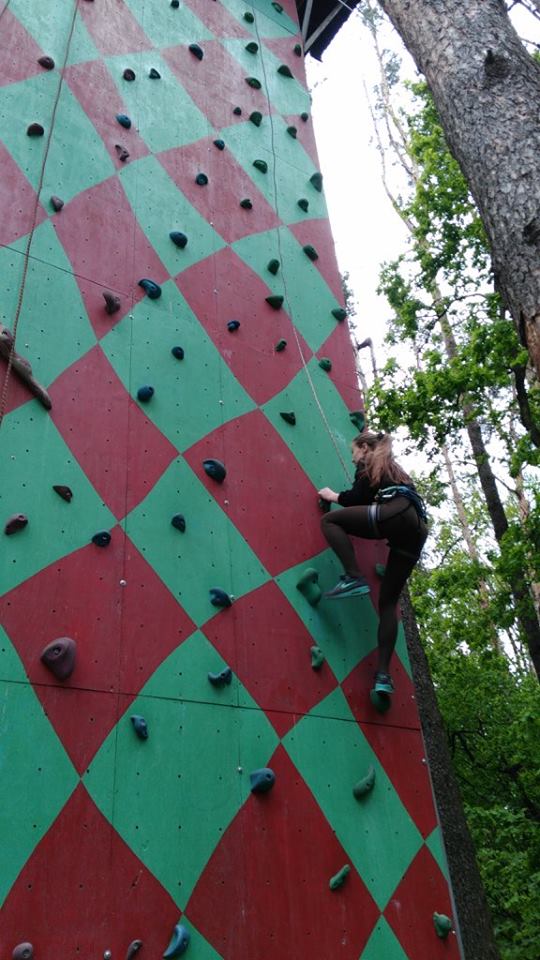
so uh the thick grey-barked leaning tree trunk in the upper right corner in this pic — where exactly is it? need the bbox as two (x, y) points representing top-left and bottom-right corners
(379, 0), (540, 376)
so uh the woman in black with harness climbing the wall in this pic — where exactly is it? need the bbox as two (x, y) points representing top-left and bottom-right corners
(319, 430), (428, 696)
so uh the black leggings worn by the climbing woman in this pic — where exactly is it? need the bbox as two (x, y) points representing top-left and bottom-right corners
(322, 497), (428, 673)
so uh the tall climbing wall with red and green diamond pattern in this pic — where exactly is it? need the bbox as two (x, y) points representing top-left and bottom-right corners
(0, 0), (459, 960)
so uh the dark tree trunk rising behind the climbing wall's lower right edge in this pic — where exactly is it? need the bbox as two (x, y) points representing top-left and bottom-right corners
(401, 590), (500, 960)
